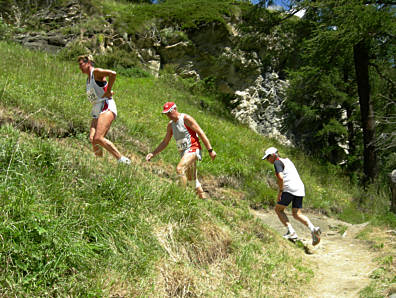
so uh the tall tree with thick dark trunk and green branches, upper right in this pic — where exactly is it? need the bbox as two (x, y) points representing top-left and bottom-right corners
(284, 0), (396, 183)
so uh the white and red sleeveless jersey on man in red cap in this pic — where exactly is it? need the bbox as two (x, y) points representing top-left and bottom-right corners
(171, 114), (201, 155)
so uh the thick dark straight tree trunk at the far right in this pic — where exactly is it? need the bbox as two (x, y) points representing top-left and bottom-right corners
(353, 40), (377, 184)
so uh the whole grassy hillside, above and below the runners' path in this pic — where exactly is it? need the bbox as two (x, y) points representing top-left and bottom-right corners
(0, 43), (394, 297)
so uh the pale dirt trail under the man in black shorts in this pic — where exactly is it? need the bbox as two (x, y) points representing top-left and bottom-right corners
(252, 211), (376, 298)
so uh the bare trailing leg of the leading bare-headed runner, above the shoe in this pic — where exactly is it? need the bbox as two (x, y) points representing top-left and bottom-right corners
(93, 111), (121, 160)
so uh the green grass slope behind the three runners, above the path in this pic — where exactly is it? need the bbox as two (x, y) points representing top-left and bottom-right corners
(0, 43), (387, 220)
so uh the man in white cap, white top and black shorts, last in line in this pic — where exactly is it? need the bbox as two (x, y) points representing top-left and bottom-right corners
(263, 147), (321, 245)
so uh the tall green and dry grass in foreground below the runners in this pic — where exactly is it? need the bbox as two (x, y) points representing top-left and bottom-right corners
(0, 126), (311, 297)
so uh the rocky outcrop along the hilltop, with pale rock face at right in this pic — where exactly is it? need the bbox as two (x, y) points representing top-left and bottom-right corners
(1, 1), (290, 144)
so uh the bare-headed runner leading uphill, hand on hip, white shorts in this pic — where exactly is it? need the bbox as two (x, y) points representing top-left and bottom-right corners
(77, 55), (131, 164)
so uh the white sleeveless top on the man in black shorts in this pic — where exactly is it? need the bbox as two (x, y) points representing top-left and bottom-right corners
(279, 158), (305, 197)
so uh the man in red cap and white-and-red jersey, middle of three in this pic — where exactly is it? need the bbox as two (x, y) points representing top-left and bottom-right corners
(146, 102), (216, 198)
